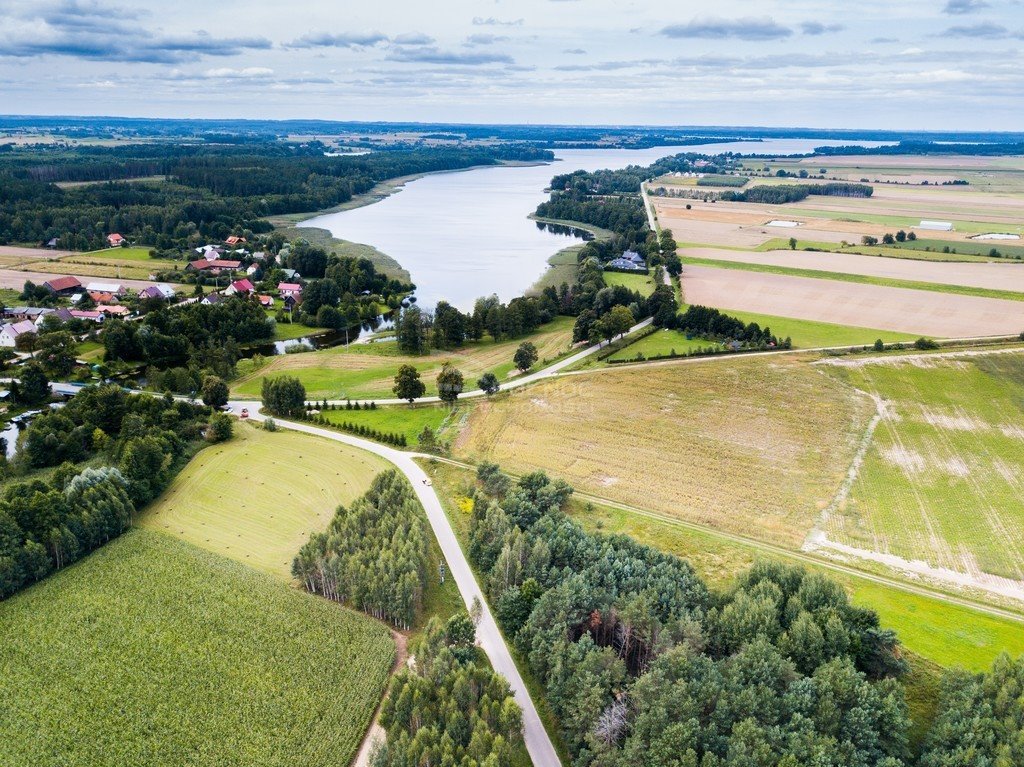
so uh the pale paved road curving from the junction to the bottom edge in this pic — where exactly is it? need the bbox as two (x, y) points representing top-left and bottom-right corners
(229, 401), (561, 767)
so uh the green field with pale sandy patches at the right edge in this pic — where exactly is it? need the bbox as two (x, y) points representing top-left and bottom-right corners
(820, 352), (1024, 581)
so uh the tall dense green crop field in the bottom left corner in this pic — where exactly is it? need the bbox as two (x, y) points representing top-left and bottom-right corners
(0, 530), (395, 767)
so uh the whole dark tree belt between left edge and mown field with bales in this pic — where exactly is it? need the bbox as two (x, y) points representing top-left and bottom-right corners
(0, 384), (210, 598)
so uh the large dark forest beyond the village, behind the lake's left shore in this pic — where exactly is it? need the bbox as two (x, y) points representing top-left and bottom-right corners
(0, 142), (551, 250)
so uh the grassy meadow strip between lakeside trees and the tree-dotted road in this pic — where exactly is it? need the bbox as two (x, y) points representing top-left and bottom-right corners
(231, 317), (573, 400)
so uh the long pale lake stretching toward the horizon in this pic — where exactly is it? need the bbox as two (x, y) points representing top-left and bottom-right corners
(299, 139), (882, 310)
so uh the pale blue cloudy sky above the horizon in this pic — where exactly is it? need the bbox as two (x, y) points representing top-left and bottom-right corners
(0, 0), (1024, 130)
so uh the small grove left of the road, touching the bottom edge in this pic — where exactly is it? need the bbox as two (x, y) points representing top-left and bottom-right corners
(370, 613), (522, 767)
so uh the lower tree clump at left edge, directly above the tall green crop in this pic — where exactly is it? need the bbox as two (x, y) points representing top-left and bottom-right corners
(0, 464), (135, 599)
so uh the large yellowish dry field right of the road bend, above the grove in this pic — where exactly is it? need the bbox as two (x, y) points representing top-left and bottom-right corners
(454, 356), (870, 546)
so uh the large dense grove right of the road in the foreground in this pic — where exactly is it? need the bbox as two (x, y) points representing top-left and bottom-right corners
(470, 464), (908, 767)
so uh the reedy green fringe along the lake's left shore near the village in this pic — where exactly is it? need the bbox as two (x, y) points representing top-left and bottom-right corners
(267, 158), (552, 283)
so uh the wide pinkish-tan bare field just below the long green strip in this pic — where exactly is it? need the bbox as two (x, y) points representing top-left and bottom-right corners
(683, 265), (1024, 338)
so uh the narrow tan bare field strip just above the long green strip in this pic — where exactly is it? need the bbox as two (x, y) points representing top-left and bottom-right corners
(682, 248), (1024, 293)
